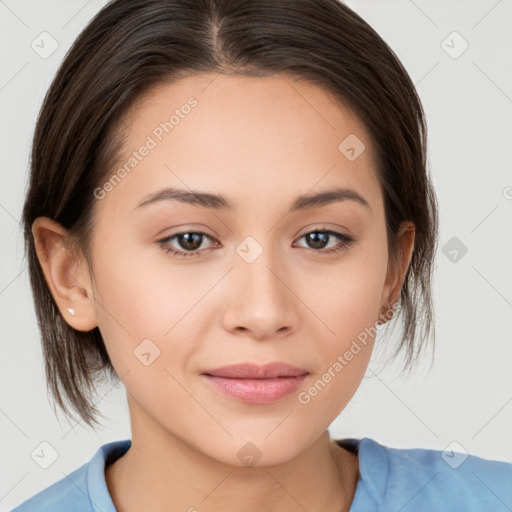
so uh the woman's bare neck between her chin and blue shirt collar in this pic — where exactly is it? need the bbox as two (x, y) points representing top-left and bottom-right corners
(105, 402), (359, 512)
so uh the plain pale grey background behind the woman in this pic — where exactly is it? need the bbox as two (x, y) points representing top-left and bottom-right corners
(0, 0), (512, 511)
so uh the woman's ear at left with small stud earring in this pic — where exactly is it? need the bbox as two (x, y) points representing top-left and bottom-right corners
(32, 217), (98, 331)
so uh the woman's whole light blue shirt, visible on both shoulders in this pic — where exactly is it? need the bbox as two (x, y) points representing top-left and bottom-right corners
(11, 437), (512, 512)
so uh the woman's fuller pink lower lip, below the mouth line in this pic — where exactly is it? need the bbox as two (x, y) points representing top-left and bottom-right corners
(202, 374), (307, 404)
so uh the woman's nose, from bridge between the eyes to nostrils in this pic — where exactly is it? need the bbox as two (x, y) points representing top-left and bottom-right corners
(223, 239), (304, 340)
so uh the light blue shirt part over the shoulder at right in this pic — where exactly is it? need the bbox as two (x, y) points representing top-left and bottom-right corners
(340, 438), (512, 512)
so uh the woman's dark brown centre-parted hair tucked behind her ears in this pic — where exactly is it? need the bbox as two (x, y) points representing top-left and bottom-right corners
(23, 0), (438, 426)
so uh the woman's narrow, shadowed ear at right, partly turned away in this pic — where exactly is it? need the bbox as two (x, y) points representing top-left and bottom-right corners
(377, 221), (416, 324)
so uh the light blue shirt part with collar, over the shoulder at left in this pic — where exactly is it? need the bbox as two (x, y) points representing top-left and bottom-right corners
(11, 439), (131, 512)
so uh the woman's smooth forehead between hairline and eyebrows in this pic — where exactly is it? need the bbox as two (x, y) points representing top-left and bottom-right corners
(100, 73), (381, 214)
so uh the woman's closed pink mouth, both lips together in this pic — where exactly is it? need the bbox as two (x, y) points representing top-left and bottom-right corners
(201, 362), (309, 404)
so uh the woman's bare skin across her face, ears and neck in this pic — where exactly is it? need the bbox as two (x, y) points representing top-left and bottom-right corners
(33, 74), (414, 512)
